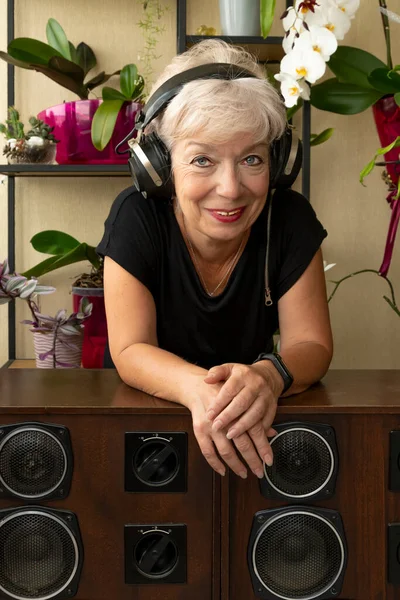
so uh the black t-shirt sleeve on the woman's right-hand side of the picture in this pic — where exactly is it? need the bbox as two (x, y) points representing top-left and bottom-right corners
(271, 190), (328, 300)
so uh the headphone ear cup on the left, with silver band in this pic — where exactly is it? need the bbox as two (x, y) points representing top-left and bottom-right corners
(128, 132), (174, 199)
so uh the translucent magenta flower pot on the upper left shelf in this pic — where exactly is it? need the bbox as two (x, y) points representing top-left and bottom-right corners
(37, 100), (142, 165)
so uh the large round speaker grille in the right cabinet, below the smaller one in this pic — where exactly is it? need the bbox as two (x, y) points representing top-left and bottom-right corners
(252, 511), (345, 600)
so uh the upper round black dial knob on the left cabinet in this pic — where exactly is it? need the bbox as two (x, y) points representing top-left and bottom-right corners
(133, 438), (179, 485)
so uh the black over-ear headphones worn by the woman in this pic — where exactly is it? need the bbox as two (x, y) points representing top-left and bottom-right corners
(116, 63), (302, 198)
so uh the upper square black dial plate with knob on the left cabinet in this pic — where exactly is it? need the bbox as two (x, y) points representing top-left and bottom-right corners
(125, 431), (187, 494)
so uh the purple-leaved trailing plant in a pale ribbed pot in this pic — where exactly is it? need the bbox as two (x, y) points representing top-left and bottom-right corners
(0, 260), (92, 369)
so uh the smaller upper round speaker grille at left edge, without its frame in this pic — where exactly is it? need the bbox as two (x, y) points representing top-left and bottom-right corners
(0, 427), (67, 499)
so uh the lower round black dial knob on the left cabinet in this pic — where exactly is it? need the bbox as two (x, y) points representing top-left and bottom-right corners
(134, 531), (178, 579)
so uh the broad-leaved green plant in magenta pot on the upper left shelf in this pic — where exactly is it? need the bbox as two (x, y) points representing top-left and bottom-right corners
(0, 19), (144, 164)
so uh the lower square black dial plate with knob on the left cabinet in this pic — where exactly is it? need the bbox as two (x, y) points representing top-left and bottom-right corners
(125, 523), (187, 584)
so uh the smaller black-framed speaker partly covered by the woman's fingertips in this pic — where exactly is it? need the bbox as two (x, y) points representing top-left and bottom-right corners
(260, 422), (339, 502)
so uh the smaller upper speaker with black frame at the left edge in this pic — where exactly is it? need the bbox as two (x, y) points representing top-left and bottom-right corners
(0, 422), (73, 501)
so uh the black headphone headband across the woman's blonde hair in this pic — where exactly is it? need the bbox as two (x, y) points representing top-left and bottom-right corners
(135, 63), (256, 130)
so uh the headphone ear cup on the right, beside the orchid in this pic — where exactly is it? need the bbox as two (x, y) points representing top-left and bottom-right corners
(270, 127), (303, 189)
